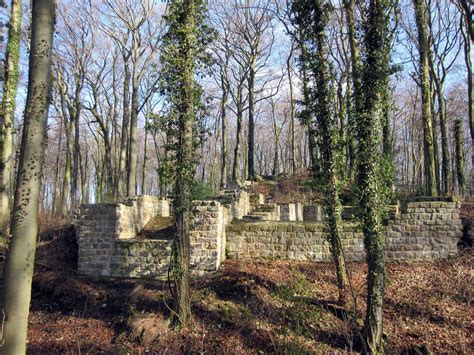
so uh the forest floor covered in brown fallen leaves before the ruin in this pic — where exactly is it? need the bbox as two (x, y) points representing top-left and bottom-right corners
(0, 216), (474, 354)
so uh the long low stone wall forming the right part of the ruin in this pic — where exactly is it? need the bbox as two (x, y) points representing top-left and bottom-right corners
(226, 202), (462, 261)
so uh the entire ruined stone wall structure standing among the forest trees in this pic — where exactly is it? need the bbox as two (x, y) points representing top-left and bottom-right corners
(75, 190), (463, 278)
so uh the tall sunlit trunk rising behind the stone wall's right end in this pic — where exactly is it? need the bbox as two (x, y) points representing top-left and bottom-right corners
(413, 0), (438, 196)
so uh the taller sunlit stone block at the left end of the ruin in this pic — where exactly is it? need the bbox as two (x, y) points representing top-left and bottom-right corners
(75, 196), (226, 278)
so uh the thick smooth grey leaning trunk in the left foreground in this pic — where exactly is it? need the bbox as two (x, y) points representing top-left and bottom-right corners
(0, 0), (55, 354)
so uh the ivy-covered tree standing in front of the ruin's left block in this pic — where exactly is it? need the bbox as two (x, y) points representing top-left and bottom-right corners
(161, 0), (207, 327)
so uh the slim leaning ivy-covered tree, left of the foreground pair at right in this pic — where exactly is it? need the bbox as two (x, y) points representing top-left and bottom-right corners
(292, 0), (349, 301)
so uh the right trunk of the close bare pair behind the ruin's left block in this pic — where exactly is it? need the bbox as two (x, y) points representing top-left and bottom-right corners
(127, 69), (139, 197)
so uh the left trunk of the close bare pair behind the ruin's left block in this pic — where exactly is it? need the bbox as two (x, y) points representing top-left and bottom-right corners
(116, 60), (131, 197)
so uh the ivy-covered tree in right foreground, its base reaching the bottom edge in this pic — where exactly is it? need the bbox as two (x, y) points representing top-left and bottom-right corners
(357, 0), (391, 353)
